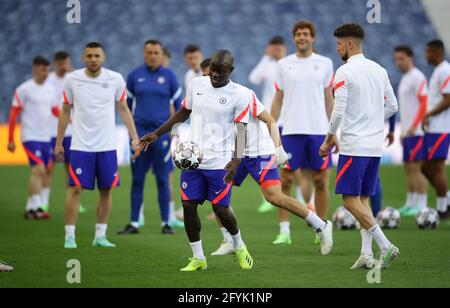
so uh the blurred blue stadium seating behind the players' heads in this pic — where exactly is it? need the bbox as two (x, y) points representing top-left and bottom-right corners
(0, 0), (436, 122)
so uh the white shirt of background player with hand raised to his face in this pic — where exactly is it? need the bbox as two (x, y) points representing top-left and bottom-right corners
(249, 55), (284, 126)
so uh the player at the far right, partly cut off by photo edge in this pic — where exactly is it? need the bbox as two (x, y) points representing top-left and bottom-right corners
(422, 40), (450, 219)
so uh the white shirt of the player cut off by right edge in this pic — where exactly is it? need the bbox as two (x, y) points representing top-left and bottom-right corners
(428, 61), (450, 134)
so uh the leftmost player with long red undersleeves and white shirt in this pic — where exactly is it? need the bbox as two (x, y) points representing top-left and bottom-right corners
(8, 56), (57, 220)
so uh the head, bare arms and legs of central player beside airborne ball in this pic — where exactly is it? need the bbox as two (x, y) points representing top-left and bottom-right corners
(141, 50), (247, 242)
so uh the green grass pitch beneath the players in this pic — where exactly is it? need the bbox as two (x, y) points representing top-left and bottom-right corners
(0, 166), (450, 288)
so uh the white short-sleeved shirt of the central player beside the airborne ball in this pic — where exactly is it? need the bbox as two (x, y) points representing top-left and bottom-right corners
(183, 77), (253, 170)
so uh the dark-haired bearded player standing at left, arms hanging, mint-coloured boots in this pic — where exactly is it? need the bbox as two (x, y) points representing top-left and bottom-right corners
(55, 42), (140, 249)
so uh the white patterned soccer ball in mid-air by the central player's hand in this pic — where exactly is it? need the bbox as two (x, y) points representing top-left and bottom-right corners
(172, 141), (203, 170)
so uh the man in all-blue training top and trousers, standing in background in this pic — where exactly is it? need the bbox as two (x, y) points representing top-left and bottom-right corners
(119, 40), (182, 235)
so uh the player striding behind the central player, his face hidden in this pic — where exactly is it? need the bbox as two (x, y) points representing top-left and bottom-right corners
(212, 93), (333, 256)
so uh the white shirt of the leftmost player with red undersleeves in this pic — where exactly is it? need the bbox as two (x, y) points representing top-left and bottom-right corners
(12, 79), (56, 142)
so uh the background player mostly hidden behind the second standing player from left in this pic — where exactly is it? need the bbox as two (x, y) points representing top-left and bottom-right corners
(41, 51), (86, 213)
